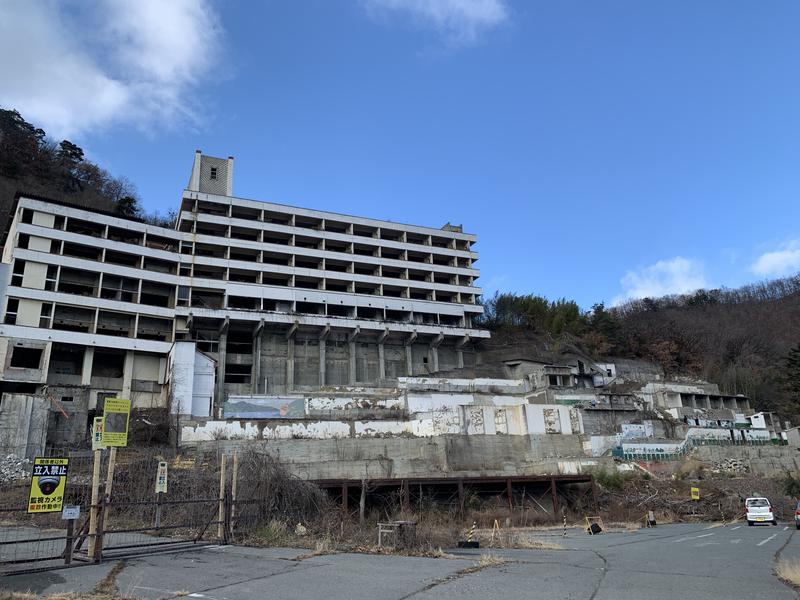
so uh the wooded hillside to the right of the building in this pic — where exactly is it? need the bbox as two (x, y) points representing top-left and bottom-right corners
(482, 282), (800, 424)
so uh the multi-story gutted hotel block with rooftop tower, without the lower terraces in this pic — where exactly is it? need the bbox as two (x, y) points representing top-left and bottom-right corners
(0, 151), (489, 440)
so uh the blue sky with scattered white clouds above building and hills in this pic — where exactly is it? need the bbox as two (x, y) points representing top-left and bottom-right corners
(0, 0), (800, 308)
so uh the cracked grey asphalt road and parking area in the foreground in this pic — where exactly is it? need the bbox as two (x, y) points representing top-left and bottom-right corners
(0, 524), (800, 600)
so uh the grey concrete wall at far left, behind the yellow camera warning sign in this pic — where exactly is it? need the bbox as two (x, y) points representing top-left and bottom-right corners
(0, 394), (49, 459)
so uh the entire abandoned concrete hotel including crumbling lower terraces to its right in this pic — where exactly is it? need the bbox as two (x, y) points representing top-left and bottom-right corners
(0, 152), (778, 485)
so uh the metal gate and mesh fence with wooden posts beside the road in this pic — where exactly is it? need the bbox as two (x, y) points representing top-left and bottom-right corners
(0, 448), (231, 576)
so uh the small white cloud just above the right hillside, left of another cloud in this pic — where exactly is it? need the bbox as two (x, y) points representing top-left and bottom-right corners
(612, 256), (709, 305)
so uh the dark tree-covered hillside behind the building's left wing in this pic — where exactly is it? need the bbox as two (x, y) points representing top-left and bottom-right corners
(0, 108), (171, 239)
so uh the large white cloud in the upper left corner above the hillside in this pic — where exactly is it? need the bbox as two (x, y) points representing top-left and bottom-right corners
(0, 0), (221, 138)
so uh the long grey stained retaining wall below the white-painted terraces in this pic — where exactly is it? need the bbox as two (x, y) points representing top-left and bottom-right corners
(197, 435), (610, 479)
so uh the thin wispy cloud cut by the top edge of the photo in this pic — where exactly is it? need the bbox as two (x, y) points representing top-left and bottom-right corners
(362, 0), (509, 44)
